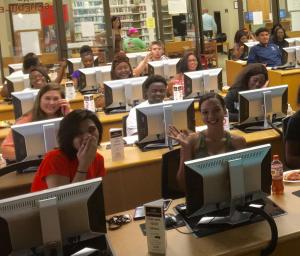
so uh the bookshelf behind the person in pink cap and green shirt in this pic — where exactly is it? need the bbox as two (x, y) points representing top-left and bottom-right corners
(109, 0), (155, 44)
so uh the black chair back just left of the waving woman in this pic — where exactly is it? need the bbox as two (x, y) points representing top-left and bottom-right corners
(161, 148), (185, 199)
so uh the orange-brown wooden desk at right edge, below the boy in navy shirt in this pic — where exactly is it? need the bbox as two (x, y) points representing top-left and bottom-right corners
(268, 69), (300, 111)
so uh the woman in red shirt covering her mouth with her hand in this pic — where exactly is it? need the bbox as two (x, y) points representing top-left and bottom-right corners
(31, 109), (105, 192)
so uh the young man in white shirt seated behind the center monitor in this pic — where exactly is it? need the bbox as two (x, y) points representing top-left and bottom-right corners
(126, 75), (167, 136)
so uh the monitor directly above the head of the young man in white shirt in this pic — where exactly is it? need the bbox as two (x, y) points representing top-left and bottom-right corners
(148, 58), (180, 79)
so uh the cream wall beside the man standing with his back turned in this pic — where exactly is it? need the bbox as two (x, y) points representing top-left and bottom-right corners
(201, 0), (239, 47)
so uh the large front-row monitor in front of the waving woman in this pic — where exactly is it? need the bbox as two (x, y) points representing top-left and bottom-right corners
(184, 144), (272, 224)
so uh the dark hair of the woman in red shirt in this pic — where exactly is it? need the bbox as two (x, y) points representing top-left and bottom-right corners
(57, 109), (103, 159)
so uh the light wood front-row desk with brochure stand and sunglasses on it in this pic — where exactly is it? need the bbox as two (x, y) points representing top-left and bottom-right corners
(108, 186), (300, 256)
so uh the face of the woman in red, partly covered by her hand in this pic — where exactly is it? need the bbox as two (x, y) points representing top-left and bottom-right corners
(73, 119), (99, 151)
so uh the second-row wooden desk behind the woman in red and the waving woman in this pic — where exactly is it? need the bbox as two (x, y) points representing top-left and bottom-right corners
(0, 130), (282, 214)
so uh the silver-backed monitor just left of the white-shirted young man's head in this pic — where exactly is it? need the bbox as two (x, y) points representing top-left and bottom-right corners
(104, 76), (147, 113)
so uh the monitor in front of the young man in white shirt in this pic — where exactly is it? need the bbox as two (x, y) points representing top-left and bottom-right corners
(136, 99), (195, 146)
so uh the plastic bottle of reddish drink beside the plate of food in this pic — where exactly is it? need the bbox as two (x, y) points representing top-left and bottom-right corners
(271, 155), (284, 195)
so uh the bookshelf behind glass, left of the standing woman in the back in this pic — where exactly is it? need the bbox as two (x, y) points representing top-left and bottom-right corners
(72, 0), (105, 42)
